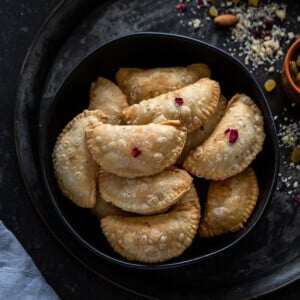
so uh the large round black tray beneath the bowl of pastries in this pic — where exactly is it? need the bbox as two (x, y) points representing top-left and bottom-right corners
(15, 0), (300, 299)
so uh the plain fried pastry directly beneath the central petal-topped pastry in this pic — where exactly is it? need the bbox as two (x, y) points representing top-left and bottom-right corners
(98, 167), (193, 215)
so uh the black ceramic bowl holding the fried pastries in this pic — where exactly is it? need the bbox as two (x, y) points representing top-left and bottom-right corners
(39, 33), (278, 269)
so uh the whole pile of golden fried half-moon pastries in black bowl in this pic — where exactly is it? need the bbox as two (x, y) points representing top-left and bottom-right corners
(52, 63), (265, 263)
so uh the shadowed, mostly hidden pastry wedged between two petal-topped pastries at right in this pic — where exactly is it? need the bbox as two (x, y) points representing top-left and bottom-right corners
(177, 95), (227, 165)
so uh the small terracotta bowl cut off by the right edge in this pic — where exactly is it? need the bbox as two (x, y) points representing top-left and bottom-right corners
(281, 39), (300, 105)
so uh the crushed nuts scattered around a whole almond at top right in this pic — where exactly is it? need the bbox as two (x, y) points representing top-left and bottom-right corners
(175, 0), (299, 73)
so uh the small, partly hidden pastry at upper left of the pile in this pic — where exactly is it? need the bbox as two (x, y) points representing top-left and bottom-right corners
(88, 77), (128, 124)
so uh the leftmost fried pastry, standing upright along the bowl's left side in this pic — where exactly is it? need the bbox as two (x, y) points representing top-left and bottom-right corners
(52, 110), (106, 208)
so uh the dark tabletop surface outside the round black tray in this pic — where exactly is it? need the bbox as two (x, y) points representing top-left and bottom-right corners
(0, 0), (300, 299)
